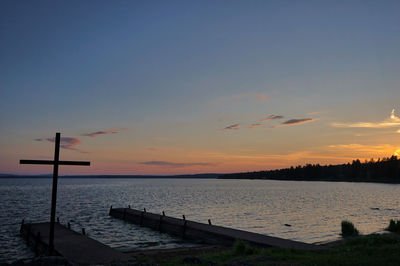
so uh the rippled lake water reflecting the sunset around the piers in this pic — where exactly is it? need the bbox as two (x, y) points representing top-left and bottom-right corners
(0, 178), (400, 262)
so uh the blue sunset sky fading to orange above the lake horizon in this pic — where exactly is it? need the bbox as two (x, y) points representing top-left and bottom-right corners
(0, 0), (400, 175)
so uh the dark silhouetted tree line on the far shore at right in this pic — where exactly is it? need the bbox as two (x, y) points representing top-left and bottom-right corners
(219, 156), (400, 183)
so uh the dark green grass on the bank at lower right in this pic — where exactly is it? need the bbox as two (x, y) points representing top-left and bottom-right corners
(152, 234), (400, 266)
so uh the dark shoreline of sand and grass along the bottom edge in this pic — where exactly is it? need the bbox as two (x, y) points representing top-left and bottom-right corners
(7, 232), (400, 266)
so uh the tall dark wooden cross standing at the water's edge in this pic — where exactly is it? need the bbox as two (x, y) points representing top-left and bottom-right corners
(19, 133), (90, 255)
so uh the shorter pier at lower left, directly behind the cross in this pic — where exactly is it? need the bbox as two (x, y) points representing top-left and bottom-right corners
(21, 223), (132, 265)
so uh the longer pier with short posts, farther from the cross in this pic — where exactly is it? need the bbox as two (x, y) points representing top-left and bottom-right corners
(109, 208), (320, 250)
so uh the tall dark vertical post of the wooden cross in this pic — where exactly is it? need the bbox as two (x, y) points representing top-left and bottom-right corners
(49, 133), (60, 255)
